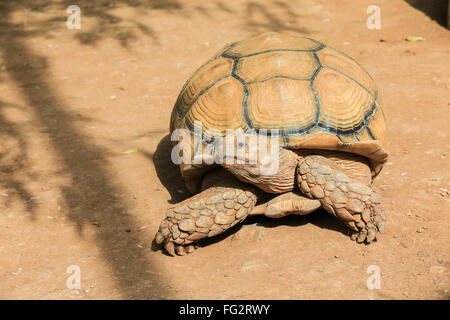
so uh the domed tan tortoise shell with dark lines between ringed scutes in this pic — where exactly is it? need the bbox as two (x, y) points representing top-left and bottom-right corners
(170, 32), (388, 191)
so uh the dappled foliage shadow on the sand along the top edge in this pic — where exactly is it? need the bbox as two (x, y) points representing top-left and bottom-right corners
(0, 0), (311, 48)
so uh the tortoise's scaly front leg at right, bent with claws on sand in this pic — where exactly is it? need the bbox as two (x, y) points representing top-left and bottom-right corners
(297, 155), (386, 243)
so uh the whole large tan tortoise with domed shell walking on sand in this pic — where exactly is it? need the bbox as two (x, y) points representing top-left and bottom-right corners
(155, 32), (388, 255)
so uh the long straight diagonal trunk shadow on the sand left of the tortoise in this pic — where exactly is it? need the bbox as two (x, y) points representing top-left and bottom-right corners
(0, 1), (174, 299)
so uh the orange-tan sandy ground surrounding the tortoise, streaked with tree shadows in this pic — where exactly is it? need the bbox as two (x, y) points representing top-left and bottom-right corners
(0, 0), (450, 299)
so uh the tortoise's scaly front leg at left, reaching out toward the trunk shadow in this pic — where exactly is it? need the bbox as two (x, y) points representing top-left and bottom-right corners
(155, 169), (256, 255)
